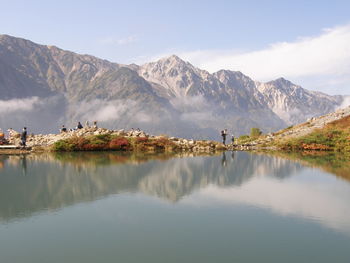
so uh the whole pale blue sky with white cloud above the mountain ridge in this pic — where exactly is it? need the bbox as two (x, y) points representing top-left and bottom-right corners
(0, 0), (350, 95)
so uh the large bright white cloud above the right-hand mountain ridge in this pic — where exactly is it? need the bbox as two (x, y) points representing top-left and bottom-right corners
(183, 25), (350, 80)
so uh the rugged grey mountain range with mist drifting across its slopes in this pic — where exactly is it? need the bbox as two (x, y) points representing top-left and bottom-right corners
(0, 35), (345, 138)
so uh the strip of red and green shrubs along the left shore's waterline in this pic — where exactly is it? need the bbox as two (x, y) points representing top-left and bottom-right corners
(52, 134), (178, 152)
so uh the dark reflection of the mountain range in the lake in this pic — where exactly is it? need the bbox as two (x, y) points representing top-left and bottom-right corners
(0, 152), (348, 228)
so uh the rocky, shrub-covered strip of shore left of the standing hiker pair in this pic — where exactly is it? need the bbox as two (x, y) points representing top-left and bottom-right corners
(0, 127), (229, 154)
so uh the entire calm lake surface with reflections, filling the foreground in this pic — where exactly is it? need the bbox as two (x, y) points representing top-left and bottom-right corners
(0, 152), (350, 263)
